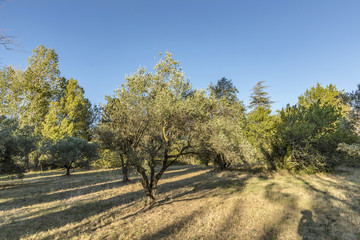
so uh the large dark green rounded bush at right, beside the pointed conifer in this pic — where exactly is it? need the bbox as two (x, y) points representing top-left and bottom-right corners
(267, 103), (355, 172)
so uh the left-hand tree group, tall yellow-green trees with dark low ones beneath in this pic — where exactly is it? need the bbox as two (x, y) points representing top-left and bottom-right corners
(0, 46), (97, 174)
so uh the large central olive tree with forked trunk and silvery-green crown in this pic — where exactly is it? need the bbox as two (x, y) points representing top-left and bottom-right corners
(103, 53), (207, 204)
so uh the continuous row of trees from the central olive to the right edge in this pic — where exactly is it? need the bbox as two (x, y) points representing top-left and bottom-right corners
(97, 53), (359, 202)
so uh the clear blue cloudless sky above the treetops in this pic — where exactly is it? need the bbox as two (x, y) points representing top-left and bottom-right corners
(0, 0), (360, 110)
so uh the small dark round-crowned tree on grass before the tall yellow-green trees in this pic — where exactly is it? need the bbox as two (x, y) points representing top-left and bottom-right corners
(42, 137), (98, 175)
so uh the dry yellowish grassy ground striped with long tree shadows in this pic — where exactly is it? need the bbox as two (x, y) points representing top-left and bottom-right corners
(0, 166), (360, 239)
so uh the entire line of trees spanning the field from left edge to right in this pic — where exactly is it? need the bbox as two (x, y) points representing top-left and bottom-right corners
(0, 46), (360, 203)
